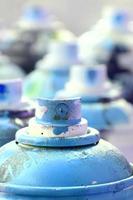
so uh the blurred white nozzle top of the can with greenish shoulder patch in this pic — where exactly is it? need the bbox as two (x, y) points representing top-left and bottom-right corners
(37, 40), (79, 70)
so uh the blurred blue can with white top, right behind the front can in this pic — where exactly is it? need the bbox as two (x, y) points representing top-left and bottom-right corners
(56, 65), (132, 130)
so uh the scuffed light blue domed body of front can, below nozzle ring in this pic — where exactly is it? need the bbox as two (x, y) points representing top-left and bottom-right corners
(0, 137), (133, 200)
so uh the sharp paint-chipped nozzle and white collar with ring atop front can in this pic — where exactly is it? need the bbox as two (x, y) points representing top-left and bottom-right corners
(16, 97), (100, 147)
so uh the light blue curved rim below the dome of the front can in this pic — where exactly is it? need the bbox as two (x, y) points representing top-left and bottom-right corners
(0, 164), (133, 197)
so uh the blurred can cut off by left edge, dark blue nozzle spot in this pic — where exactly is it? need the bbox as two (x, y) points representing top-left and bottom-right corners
(0, 80), (34, 146)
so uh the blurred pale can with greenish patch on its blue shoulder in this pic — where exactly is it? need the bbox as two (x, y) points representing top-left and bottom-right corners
(24, 41), (78, 98)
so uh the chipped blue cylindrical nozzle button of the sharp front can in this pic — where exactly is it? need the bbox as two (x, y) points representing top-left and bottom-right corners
(36, 98), (81, 128)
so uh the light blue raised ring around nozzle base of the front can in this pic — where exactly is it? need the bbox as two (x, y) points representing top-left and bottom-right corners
(16, 128), (100, 148)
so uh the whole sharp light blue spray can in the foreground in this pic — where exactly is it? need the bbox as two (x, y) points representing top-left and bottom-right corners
(0, 98), (133, 200)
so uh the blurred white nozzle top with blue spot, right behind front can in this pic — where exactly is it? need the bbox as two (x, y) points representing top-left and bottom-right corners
(57, 65), (121, 101)
